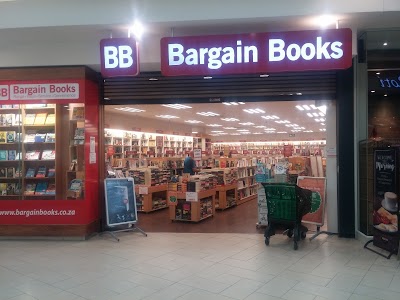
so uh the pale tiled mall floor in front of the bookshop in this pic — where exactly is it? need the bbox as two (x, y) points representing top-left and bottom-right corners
(0, 233), (400, 300)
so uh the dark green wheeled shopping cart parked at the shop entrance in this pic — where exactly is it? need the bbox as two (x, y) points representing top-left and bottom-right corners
(263, 183), (312, 250)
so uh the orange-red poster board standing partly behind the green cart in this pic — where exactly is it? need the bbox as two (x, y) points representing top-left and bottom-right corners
(297, 176), (326, 226)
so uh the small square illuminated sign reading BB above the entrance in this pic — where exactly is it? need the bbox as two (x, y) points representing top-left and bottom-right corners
(100, 38), (139, 78)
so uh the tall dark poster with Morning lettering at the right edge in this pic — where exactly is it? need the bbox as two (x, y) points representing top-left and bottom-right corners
(373, 149), (398, 252)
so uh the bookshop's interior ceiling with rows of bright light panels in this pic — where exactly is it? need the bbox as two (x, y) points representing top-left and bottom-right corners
(105, 100), (329, 140)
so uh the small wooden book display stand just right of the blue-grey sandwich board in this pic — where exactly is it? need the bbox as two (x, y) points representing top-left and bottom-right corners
(135, 184), (168, 213)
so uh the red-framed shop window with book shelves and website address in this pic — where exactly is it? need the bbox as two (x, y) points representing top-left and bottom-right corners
(0, 67), (99, 238)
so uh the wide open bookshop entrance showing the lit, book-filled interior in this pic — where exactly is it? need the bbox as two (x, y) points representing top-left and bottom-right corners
(104, 99), (337, 233)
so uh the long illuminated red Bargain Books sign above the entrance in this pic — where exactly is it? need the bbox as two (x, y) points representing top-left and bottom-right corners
(161, 29), (352, 76)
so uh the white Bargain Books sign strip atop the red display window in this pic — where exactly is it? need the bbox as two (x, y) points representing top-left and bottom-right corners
(0, 80), (80, 102)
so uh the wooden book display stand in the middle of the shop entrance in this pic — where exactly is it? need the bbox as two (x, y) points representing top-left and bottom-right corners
(168, 189), (216, 222)
